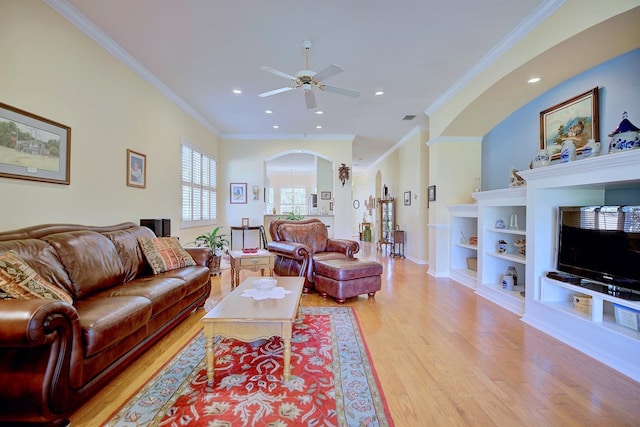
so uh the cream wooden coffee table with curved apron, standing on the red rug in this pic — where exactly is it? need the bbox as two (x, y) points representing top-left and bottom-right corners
(202, 277), (304, 385)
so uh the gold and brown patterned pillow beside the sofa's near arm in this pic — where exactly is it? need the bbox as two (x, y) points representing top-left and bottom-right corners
(0, 251), (73, 304)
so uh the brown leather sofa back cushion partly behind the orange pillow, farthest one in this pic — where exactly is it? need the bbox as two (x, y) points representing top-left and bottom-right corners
(103, 227), (156, 282)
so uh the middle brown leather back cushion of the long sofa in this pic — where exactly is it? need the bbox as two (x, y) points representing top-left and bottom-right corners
(42, 230), (125, 300)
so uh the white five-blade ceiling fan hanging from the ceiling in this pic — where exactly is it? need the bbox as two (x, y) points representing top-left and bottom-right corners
(258, 40), (360, 109)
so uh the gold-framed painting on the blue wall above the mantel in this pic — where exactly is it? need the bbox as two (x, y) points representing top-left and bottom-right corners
(540, 87), (600, 160)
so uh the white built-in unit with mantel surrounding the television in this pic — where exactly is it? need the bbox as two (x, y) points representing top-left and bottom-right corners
(520, 150), (640, 381)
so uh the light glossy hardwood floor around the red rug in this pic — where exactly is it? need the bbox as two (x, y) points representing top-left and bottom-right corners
(71, 242), (640, 427)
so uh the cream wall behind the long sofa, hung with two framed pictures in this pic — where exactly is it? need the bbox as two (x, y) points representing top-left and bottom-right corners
(0, 0), (219, 240)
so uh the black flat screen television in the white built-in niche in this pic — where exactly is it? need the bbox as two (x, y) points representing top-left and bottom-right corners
(557, 206), (640, 299)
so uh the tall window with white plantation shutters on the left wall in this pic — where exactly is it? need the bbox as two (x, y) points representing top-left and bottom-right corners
(182, 143), (217, 227)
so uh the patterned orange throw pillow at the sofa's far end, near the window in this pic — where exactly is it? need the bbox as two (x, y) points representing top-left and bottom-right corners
(138, 237), (196, 274)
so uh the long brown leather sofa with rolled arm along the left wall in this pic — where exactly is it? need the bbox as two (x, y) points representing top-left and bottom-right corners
(0, 223), (212, 426)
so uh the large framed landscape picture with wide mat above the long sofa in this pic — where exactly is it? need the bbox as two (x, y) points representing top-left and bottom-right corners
(0, 102), (71, 185)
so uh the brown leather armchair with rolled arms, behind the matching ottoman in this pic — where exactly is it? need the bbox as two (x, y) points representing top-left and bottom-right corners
(268, 218), (360, 292)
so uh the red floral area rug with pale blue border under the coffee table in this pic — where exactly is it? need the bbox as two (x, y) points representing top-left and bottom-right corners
(106, 307), (393, 427)
